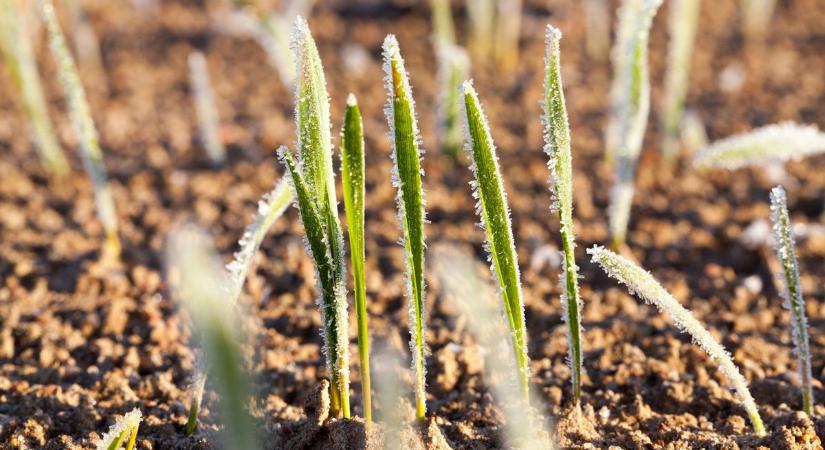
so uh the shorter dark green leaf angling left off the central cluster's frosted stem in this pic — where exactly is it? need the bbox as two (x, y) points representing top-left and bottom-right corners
(278, 147), (349, 418)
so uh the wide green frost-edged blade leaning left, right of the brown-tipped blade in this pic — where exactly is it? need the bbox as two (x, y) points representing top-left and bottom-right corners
(461, 81), (530, 400)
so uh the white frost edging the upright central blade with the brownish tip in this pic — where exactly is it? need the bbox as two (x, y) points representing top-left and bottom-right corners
(382, 34), (428, 414)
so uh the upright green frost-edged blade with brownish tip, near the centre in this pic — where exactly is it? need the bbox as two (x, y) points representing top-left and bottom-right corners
(383, 35), (427, 423)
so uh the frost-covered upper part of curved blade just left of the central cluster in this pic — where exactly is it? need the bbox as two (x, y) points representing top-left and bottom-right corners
(226, 179), (292, 304)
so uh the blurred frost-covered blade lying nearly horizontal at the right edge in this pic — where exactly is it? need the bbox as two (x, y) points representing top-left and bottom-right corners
(693, 122), (825, 169)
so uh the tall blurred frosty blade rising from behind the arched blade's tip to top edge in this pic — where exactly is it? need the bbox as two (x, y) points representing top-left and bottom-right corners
(607, 0), (662, 247)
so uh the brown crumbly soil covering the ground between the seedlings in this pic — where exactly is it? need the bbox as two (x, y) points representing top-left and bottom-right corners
(0, 0), (825, 449)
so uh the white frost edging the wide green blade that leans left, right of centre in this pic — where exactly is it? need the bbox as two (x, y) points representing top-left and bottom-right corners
(459, 80), (530, 390)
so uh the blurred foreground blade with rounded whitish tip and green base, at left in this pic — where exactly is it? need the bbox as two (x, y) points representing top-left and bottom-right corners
(171, 225), (260, 450)
